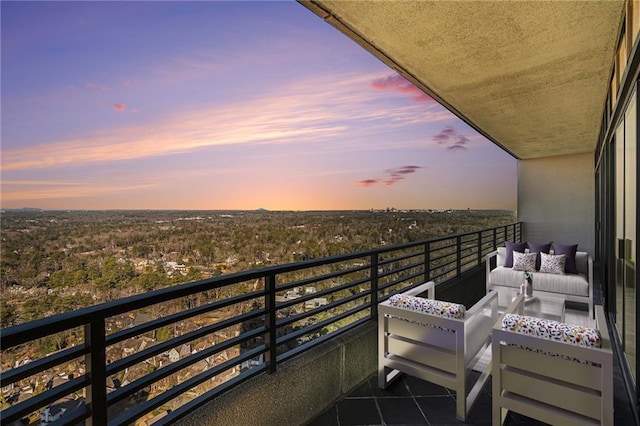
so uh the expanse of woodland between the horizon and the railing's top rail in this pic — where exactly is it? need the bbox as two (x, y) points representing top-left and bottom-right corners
(0, 209), (515, 327)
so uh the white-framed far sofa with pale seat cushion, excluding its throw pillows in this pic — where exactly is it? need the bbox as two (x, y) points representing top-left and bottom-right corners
(486, 247), (593, 318)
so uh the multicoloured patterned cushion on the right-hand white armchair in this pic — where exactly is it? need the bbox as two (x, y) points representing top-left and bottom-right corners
(502, 314), (602, 348)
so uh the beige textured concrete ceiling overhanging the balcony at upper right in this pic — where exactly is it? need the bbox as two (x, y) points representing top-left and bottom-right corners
(301, 0), (624, 159)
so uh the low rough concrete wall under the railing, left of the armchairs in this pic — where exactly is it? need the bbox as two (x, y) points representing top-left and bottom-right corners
(178, 321), (378, 426)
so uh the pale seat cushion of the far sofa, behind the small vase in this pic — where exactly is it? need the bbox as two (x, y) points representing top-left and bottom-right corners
(489, 266), (589, 297)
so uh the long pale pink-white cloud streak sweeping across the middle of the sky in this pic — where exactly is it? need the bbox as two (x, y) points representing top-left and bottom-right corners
(2, 74), (450, 171)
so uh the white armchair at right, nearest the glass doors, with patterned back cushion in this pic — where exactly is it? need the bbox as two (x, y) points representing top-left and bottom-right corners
(491, 295), (613, 426)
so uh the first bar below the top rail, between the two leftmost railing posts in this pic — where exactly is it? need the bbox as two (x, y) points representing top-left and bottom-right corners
(105, 291), (264, 346)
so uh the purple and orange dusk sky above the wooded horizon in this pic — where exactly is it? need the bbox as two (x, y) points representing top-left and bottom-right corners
(0, 1), (517, 210)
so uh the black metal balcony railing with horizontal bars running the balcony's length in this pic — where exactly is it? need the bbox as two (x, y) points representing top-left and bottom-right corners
(0, 223), (522, 425)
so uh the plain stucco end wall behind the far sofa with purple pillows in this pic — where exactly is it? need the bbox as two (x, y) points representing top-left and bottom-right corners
(518, 154), (595, 256)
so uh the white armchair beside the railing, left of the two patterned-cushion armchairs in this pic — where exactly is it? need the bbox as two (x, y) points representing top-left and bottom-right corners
(378, 281), (498, 421)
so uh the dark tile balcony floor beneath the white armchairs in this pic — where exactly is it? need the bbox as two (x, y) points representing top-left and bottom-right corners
(308, 362), (637, 426)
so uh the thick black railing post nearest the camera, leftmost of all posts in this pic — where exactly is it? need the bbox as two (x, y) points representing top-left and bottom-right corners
(84, 318), (107, 426)
